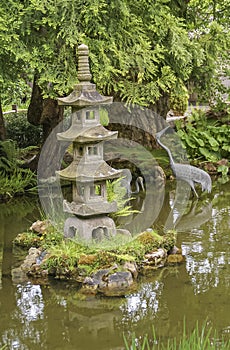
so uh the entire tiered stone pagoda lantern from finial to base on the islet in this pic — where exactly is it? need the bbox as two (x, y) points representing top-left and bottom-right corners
(57, 45), (121, 240)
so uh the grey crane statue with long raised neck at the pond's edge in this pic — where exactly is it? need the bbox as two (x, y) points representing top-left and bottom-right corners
(156, 126), (212, 197)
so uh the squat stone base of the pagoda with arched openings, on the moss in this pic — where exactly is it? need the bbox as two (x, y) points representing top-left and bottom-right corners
(64, 216), (116, 242)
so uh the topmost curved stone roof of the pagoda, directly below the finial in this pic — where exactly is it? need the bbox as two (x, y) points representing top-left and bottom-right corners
(57, 81), (113, 108)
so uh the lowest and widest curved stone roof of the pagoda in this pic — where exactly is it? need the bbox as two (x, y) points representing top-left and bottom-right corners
(56, 160), (122, 183)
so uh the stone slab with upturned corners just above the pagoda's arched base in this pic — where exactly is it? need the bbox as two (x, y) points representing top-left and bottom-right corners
(63, 200), (117, 216)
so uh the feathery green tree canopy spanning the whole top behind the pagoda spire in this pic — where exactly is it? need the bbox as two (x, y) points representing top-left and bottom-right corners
(0, 0), (229, 114)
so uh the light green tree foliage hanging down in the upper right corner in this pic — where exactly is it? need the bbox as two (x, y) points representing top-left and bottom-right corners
(186, 0), (230, 103)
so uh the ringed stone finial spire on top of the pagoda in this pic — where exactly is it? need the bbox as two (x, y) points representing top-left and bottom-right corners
(77, 44), (92, 82)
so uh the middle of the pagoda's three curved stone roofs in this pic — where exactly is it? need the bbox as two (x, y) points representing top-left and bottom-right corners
(57, 124), (118, 143)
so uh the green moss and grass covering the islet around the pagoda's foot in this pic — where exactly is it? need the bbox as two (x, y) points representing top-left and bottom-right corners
(14, 227), (176, 290)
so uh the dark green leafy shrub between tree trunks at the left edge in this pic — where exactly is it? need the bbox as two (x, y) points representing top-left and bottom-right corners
(5, 113), (42, 148)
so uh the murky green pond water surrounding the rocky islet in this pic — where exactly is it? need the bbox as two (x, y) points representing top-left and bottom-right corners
(0, 183), (230, 350)
